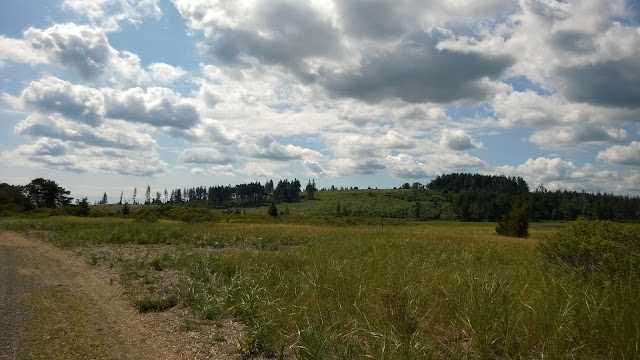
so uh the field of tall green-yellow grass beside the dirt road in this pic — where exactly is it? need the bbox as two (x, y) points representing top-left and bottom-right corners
(0, 217), (640, 359)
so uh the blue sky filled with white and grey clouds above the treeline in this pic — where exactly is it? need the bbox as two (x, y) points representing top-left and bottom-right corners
(0, 0), (640, 202)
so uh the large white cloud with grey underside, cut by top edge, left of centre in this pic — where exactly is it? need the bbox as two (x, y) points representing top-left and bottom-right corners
(173, 0), (341, 77)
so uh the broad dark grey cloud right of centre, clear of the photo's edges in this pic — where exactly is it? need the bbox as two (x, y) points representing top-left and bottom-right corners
(321, 32), (513, 103)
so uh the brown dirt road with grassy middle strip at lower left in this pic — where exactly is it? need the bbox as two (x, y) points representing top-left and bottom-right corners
(0, 231), (227, 360)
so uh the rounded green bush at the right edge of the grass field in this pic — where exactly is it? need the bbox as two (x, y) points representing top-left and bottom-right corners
(539, 219), (640, 277)
